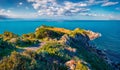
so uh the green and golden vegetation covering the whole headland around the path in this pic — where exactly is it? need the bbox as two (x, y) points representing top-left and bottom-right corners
(0, 25), (112, 70)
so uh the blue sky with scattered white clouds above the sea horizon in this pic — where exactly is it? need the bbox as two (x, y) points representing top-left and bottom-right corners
(0, 0), (120, 20)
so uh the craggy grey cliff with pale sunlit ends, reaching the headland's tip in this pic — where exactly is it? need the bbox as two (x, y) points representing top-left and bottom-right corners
(60, 30), (101, 45)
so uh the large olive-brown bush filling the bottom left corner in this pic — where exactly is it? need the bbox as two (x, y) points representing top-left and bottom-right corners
(0, 52), (37, 70)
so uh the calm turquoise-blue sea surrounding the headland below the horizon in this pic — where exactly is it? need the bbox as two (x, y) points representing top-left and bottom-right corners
(0, 20), (120, 60)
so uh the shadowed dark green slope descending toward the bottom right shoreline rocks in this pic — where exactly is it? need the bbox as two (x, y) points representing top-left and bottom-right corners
(71, 42), (113, 70)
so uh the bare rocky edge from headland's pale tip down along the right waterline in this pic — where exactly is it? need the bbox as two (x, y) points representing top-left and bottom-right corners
(60, 30), (120, 70)
